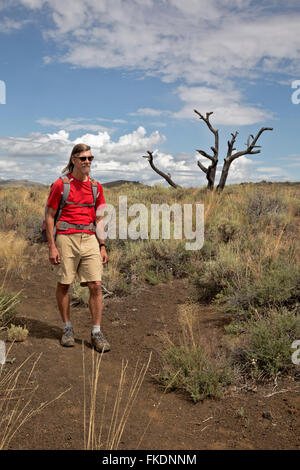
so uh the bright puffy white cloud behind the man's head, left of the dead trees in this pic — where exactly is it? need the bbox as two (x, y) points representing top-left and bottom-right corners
(0, 126), (165, 183)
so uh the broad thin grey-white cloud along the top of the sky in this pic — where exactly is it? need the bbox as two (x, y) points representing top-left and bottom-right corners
(17, 0), (300, 85)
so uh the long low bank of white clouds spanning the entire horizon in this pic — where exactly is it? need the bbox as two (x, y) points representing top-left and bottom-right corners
(0, 126), (294, 186)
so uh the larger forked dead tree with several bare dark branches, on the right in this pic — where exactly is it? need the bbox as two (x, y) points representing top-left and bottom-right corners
(194, 109), (273, 192)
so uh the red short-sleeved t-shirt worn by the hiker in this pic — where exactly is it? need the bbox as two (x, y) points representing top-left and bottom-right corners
(47, 173), (106, 234)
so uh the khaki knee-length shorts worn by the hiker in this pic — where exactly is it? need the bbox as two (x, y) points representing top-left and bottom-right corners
(55, 232), (103, 286)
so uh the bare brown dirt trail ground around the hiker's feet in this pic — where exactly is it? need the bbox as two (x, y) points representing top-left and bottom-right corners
(1, 246), (300, 450)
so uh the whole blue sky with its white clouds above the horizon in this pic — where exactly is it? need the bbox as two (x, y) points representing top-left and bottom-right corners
(0, 0), (300, 186)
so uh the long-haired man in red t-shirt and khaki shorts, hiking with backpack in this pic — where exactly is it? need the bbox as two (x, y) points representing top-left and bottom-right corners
(45, 144), (110, 352)
